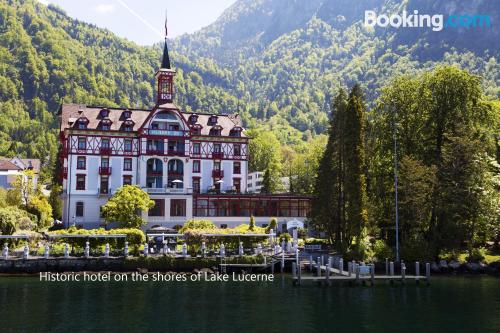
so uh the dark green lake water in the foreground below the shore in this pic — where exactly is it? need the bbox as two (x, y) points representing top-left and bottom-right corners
(0, 275), (500, 333)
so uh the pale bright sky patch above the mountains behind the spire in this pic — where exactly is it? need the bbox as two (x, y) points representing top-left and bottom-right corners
(39, 0), (235, 45)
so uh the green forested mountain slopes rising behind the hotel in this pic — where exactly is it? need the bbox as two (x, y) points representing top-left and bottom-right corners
(0, 0), (500, 179)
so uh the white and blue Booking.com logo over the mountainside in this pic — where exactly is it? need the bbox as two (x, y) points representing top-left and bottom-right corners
(365, 10), (491, 31)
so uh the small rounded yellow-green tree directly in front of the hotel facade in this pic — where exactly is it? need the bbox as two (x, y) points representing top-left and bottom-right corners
(102, 185), (154, 228)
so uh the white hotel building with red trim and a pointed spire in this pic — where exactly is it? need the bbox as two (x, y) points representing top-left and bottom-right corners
(59, 35), (309, 228)
